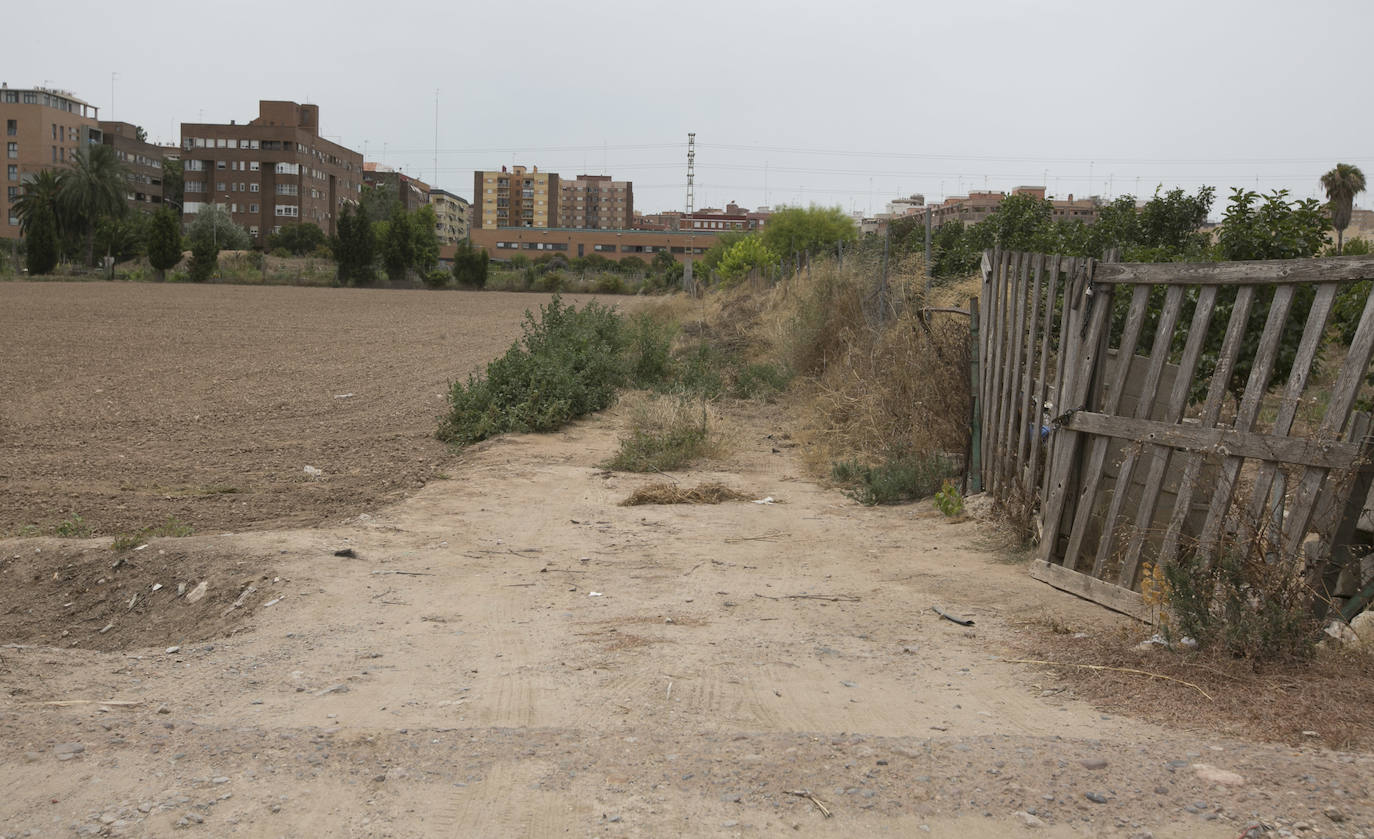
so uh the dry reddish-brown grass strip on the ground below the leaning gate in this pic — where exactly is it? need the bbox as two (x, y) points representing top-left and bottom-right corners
(1020, 623), (1374, 751)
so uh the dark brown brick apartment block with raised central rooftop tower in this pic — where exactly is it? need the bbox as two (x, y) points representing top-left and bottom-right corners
(181, 100), (363, 242)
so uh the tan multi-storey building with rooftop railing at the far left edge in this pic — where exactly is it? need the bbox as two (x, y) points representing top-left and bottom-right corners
(0, 84), (100, 239)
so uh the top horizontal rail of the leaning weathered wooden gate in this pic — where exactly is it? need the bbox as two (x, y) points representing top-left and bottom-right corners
(1094, 257), (1374, 286)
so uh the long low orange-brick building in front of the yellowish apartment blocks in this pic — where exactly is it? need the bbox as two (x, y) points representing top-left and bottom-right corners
(471, 227), (717, 262)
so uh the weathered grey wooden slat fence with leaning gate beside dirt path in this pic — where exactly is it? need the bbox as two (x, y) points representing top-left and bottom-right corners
(976, 251), (1374, 618)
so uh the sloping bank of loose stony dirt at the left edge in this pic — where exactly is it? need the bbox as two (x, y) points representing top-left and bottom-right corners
(0, 538), (283, 651)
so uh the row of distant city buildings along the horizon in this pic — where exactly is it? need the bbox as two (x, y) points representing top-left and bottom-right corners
(8, 82), (1374, 260)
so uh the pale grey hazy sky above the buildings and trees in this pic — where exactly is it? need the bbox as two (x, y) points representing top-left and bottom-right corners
(0, 0), (1374, 214)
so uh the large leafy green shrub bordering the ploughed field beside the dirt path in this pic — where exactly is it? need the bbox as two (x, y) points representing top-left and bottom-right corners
(438, 295), (629, 445)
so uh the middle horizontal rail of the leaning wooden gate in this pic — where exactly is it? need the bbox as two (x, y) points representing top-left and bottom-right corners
(1065, 411), (1359, 468)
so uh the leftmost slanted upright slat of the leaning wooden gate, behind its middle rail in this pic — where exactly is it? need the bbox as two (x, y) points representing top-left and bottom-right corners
(1040, 260), (1112, 562)
